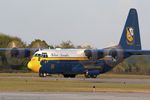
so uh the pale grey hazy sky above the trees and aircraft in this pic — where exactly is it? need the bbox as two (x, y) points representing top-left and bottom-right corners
(0, 0), (150, 49)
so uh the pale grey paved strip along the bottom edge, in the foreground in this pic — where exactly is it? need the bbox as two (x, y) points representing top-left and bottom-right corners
(0, 92), (150, 100)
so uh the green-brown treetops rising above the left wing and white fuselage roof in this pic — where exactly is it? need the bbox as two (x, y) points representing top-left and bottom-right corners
(0, 33), (92, 49)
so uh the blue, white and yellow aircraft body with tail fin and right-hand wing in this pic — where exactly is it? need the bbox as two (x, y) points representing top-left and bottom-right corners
(28, 8), (150, 78)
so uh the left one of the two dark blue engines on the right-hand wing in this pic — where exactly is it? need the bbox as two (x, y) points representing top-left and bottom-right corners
(84, 50), (104, 60)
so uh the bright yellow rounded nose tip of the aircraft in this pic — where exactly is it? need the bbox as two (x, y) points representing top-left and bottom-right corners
(27, 61), (41, 73)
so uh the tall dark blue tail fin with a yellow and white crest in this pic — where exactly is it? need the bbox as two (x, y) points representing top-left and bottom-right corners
(119, 8), (141, 50)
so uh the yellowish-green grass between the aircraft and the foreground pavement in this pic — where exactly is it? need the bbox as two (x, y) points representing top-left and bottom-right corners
(0, 73), (150, 92)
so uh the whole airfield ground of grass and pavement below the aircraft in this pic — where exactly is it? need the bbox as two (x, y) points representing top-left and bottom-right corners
(0, 74), (150, 96)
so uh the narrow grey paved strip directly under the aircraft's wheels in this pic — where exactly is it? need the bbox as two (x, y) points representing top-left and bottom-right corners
(0, 76), (150, 84)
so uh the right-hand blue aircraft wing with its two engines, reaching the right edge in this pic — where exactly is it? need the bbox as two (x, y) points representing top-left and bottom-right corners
(84, 48), (150, 60)
